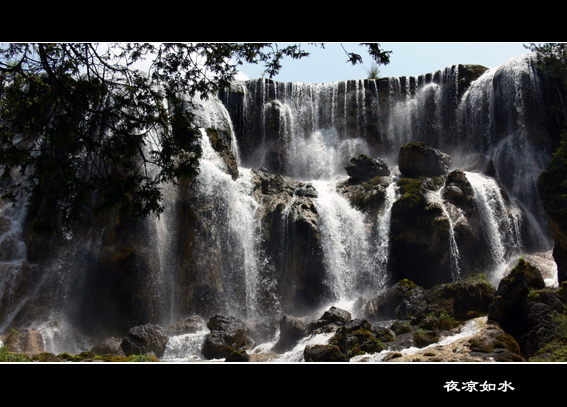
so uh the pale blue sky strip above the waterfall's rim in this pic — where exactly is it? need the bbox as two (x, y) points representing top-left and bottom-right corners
(235, 42), (529, 83)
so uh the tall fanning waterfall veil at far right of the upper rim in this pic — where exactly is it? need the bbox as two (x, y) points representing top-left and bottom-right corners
(455, 54), (551, 234)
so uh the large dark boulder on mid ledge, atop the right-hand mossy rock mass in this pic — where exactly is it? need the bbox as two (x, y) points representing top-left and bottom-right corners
(398, 142), (451, 178)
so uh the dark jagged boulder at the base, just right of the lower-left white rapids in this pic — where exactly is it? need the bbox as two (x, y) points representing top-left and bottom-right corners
(201, 314), (252, 359)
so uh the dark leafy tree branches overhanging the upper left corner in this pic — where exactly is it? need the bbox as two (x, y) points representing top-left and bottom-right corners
(0, 43), (390, 230)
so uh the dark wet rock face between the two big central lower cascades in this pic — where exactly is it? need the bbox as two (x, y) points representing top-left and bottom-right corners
(252, 169), (327, 314)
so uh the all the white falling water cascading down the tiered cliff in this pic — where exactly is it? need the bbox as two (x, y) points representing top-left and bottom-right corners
(0, 52), (551, 360)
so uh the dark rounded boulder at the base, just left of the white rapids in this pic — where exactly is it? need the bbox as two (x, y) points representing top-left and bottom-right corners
(120, 324), (169, 358)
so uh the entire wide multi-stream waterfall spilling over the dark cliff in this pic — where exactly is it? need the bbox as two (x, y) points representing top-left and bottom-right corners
(0, 51), (564, 360)
